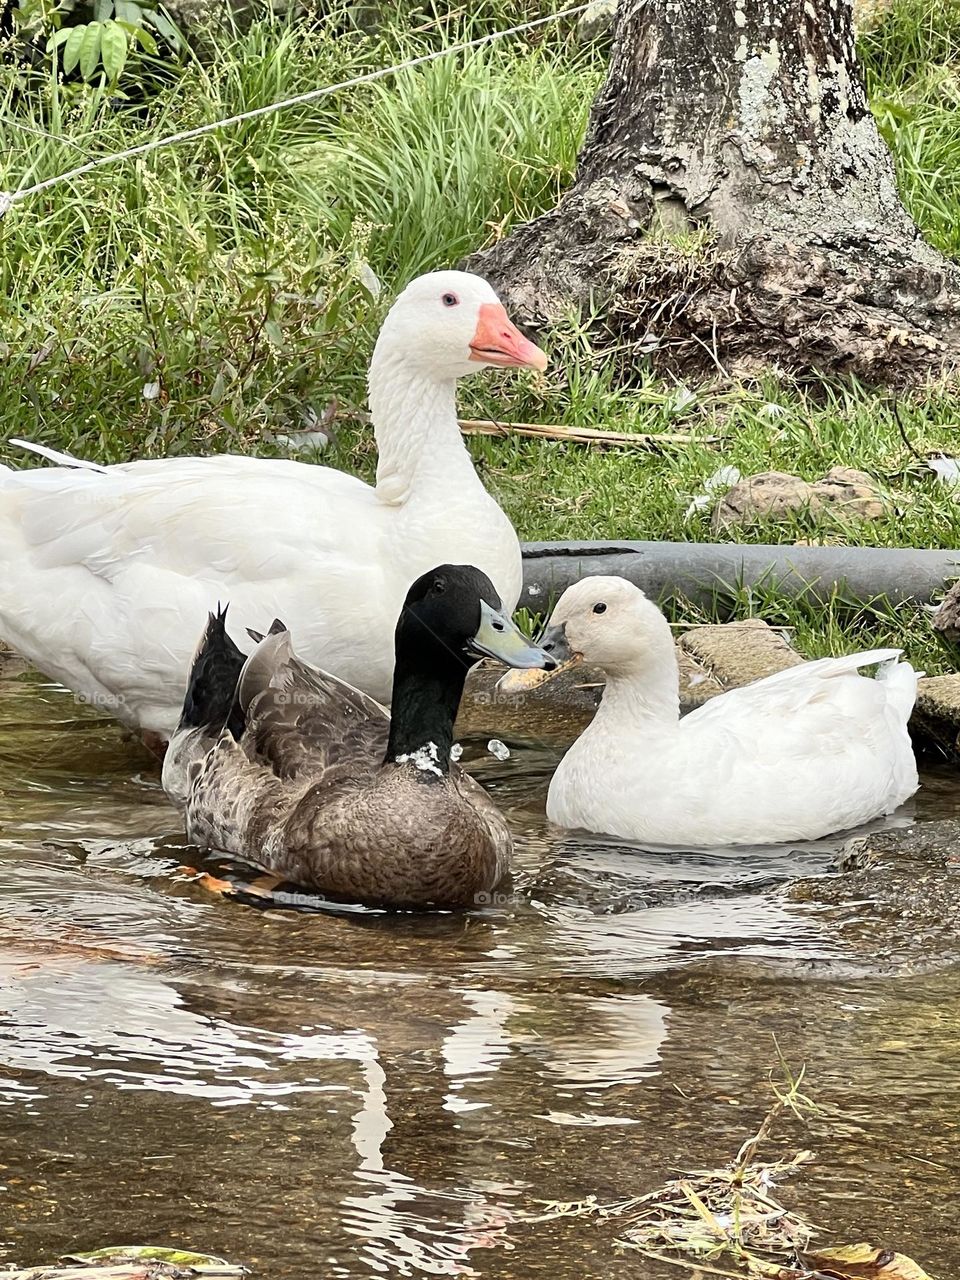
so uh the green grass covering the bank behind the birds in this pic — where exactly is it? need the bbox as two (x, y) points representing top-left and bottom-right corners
(0, 0), (960, 671)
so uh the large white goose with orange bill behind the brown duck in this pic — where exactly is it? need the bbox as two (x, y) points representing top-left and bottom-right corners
(0, 271), (547, 740)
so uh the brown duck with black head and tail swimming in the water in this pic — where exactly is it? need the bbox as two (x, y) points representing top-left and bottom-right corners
(164, 564), (554, 908)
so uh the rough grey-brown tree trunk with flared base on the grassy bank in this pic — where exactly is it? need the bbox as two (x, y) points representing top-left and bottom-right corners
(468, 0), (960, 384)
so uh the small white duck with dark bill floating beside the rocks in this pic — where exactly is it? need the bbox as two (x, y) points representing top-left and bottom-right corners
(500, 577), (918, 849)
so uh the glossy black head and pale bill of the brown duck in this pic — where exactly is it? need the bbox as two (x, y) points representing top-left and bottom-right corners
(397, 564), (556, 671)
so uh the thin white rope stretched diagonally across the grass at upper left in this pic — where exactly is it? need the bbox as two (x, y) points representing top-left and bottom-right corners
(0, 4), (590, 218)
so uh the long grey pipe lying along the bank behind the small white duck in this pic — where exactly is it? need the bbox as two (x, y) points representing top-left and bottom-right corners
(520, 543), (960, 617)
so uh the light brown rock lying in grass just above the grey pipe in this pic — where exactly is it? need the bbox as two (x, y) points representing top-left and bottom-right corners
(710, 467), (886, 532)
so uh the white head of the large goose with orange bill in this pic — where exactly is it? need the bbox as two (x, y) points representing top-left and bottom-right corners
(378, 271), (547, 381)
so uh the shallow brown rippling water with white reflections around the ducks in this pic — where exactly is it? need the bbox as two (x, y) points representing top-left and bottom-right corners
(0, 669), (960, 1280)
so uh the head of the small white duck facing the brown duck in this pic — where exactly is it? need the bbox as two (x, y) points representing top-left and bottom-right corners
(499, 575), (673, 692)
